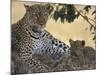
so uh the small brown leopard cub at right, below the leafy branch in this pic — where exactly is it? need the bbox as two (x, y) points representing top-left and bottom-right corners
(69, 39), (96, 70)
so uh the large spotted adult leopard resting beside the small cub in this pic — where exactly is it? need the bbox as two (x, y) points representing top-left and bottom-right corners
(11, 4), (70, 74)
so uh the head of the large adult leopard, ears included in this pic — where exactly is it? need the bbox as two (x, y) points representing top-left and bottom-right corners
(24, 4), (53, 28)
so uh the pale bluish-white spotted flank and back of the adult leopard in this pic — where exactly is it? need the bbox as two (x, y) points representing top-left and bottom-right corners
(32, 30), (70, 63)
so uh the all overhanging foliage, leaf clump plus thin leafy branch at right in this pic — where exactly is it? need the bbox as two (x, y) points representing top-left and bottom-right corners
(52, 4), (96, 40)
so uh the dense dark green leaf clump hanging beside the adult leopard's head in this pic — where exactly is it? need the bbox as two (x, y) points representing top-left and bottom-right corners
(53, 4), (79, 23)
